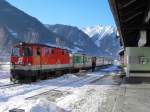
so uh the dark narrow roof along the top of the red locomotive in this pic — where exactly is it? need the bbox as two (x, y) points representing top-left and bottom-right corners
(14, 43), (69, 51)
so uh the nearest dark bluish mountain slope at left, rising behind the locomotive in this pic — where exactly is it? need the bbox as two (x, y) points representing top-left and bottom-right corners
(0, 0), (83, 61)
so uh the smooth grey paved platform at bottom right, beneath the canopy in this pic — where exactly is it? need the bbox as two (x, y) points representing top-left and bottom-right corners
(112, 83), (150, 112)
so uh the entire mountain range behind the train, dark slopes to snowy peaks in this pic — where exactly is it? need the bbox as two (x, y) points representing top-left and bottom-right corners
(0, 0), (118, 61)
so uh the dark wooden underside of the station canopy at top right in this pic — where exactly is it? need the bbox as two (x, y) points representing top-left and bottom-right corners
(109, 0), (150, 47)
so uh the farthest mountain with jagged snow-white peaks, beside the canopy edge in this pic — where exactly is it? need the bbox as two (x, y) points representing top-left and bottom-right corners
(82, 25), (120, 58)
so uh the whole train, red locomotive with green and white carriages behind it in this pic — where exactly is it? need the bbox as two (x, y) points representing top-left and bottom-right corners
(10, 43), (112, 82)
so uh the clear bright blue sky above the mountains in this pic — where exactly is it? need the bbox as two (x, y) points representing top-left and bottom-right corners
(7, 0), (115, 28)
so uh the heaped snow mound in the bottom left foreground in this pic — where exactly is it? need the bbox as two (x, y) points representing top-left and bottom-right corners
(0, 96), (69, 112)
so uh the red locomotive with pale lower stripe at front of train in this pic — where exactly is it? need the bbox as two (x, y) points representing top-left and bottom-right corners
(11, 43), (70, 80)
